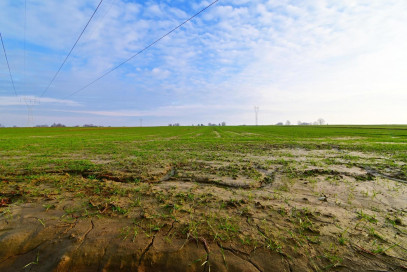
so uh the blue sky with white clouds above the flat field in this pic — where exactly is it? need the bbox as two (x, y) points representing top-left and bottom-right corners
(0, 0), (407, 126)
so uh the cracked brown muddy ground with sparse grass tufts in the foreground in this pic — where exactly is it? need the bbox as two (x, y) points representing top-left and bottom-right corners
(0, 144), (407, 271)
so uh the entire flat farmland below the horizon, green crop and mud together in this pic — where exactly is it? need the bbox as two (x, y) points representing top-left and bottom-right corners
(0, 126), (407, 271)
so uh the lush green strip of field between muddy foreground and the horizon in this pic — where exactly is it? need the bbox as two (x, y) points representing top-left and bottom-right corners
(0, 126), (407, 175)
